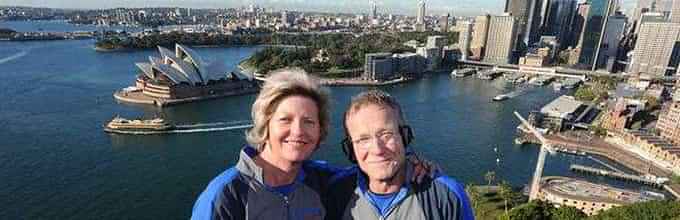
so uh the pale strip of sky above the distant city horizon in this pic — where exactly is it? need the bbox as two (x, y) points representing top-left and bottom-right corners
(0, 0), (636, 16)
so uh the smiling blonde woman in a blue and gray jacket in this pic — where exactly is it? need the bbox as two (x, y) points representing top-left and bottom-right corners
(191, 69), (430, 219)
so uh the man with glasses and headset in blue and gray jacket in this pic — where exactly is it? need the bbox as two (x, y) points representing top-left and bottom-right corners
(327, 90), (474, 220)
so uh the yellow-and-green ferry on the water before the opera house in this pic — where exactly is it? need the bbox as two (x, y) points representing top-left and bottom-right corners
(104, 116), (175, 133)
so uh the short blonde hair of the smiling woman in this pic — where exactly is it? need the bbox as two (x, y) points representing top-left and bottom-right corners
(246, 68), (330, 151)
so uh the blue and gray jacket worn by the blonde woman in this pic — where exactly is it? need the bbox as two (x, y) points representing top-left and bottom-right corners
(191, 147), (335, 220)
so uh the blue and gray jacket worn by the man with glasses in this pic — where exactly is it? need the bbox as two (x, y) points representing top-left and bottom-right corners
(326, 164), (475, 220)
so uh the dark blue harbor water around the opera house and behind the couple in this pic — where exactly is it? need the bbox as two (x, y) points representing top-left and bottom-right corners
(0, 22), (664, 219)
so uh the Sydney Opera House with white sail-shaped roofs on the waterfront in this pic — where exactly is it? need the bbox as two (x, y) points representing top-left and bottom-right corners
(114, 44), (258, 106)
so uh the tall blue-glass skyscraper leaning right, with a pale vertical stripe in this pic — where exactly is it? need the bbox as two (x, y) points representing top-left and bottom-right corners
(578, 0), (615, 70)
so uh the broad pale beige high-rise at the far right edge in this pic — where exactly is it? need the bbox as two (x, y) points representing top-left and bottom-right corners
(629, 22), (680, 75)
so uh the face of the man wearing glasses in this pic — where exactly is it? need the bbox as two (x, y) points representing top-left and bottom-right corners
(347, 104), (405, 181)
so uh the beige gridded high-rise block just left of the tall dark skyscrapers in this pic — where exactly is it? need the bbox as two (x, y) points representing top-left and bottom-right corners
(484, 15), (518, 64)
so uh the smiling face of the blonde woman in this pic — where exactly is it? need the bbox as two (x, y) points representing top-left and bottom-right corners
(267, 95), (321, 162)
